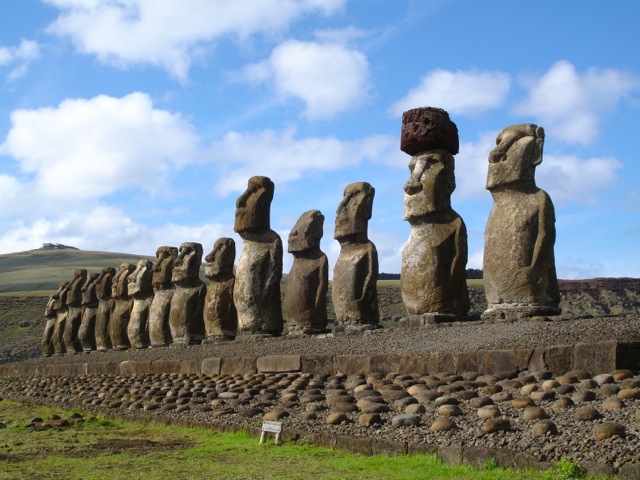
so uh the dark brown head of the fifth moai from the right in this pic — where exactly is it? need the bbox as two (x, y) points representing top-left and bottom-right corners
(233, 177), (275, 234)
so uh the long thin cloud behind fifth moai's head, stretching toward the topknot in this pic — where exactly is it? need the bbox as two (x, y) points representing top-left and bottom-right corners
(211, 128), (397, 195)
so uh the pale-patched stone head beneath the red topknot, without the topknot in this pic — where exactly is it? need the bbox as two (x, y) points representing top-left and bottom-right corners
(403, 150), (456, 222)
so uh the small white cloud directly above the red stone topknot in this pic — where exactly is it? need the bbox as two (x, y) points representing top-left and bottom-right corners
(391, 69), (511, 115)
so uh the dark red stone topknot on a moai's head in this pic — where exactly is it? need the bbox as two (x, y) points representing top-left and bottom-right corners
(400, 107), (459, 155)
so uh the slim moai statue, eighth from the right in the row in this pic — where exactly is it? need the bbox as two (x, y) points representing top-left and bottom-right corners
(149, 246), (178, 347)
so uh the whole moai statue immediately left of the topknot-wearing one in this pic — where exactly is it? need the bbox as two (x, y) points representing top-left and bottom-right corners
(331, 182), (380, 330)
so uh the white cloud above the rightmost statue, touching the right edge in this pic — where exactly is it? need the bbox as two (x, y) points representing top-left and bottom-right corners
(516, 60), (640, 145)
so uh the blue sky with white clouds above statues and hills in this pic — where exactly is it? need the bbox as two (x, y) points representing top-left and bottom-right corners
(0, 0), (640, 279)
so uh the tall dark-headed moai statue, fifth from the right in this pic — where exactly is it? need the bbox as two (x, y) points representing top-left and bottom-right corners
(233, 177), (284, 335)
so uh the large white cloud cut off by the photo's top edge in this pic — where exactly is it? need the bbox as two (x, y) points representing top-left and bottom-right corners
(44, 0), (345, 80)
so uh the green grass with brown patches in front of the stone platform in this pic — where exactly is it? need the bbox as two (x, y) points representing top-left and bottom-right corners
(0, 400), (604, 480)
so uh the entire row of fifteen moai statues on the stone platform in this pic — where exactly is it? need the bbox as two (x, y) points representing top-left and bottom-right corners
(42, 107), (560, 355)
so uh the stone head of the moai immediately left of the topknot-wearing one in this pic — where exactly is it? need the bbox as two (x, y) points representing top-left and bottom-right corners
(334, 182), (376, 241)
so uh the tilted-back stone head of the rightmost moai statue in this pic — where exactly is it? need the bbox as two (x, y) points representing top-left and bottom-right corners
(487, 123), (544, 190)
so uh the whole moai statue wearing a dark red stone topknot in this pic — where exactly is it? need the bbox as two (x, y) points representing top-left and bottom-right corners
(400, 107), (470, 323)
